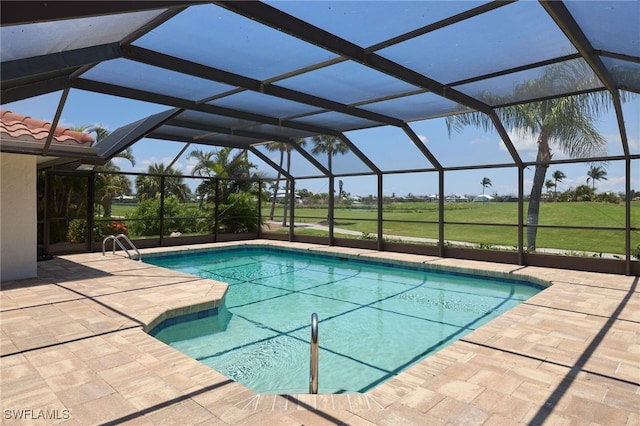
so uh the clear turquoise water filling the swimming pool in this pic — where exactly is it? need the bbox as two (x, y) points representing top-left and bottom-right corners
(145, 248), (543, 394)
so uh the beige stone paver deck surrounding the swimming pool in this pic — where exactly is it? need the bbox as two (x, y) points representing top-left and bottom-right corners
(0, 241), (640, 426)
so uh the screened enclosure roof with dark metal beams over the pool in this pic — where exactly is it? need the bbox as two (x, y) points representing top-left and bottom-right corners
(0, 1), (640, 175)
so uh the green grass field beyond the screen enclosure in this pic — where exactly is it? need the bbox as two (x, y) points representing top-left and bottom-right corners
(112, 201), (640, 254)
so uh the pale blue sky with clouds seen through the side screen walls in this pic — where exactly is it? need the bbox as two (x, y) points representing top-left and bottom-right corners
(2, 90), (640, 196)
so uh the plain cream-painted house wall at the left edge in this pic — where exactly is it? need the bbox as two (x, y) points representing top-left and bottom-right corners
(0, 153), (38, 281)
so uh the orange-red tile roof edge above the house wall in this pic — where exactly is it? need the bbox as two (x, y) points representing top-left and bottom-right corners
(0, 110), (93, 146)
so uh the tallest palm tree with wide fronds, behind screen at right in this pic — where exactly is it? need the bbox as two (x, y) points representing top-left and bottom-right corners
(446, 61), (626, 251)
